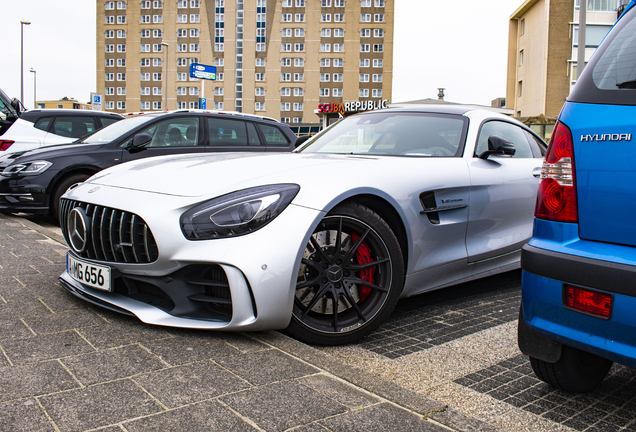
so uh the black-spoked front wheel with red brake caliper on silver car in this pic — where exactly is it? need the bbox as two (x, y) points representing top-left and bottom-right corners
(286, 203), (404, 345)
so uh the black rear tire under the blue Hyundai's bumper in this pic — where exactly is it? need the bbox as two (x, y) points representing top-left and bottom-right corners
(530, 345), (613, 393)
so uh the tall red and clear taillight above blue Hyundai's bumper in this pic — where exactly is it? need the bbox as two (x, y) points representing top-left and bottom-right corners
(534, 122), (579, 222)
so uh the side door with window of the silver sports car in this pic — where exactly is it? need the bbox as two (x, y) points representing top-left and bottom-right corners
(466, 120), (543, 263)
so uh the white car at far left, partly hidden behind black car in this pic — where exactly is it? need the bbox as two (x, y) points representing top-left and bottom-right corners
(0, 109), (124, 154)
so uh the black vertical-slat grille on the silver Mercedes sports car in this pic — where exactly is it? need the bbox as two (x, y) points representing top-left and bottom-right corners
(60, 199), (159, 264)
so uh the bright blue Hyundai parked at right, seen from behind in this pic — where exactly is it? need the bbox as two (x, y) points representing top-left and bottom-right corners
(519, 0), (636, 392)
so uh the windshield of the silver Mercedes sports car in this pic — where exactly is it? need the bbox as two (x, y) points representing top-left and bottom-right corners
(300, 111), (467, 157)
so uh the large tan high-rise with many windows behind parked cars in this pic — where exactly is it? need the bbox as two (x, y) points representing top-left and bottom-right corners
(97, 0), (394, 124)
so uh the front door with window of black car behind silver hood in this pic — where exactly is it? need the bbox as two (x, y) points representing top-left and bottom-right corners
(121, 116), (205, 162)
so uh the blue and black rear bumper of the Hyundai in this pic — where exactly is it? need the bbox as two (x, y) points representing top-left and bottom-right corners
(521, 245), (636, 368)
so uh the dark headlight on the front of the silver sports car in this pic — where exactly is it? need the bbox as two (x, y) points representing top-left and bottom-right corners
(181, 184), (300, 240)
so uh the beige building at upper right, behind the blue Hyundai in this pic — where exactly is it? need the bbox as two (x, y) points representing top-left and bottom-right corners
(506, 0), (627, 119)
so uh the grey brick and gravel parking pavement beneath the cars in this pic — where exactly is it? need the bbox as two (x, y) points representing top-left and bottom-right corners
(0, 215), (636, 432)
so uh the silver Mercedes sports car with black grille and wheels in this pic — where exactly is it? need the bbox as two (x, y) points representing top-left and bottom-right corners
(60, 106), (545, 344)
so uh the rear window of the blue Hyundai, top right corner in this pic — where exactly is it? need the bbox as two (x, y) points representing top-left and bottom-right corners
(568, 7), (636, 105)
